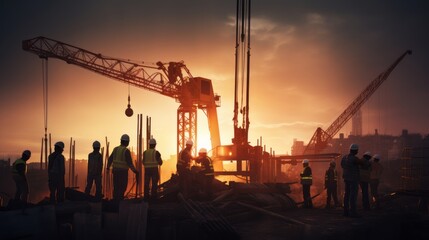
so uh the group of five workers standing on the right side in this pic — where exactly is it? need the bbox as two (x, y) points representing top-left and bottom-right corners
(300, 144), (383, 217)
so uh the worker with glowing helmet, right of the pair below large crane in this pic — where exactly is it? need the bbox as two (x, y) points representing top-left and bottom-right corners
(195, 148), (214, 199)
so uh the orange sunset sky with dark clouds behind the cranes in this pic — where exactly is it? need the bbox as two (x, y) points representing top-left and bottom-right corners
(0, 0), (429, 164)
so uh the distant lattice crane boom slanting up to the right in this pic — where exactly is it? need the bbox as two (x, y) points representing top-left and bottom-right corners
(304, 50), (412, 154)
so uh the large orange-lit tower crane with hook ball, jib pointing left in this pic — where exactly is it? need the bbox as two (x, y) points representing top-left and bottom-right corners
(22, 37), (220, 162)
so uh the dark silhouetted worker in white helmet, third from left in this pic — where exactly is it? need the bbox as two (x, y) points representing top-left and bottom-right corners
(85, 141), (103, 201)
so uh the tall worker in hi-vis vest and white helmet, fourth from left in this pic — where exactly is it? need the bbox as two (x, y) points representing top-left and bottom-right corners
(107, 134), (139, 201)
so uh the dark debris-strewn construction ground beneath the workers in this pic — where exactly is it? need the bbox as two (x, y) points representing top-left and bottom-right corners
(0, 184), (429, 240)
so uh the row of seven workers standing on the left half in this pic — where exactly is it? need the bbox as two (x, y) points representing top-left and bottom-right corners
(12, 134), (214, 203)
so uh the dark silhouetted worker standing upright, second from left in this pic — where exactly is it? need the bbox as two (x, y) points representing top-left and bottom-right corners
(48, 142), (66, 203)
